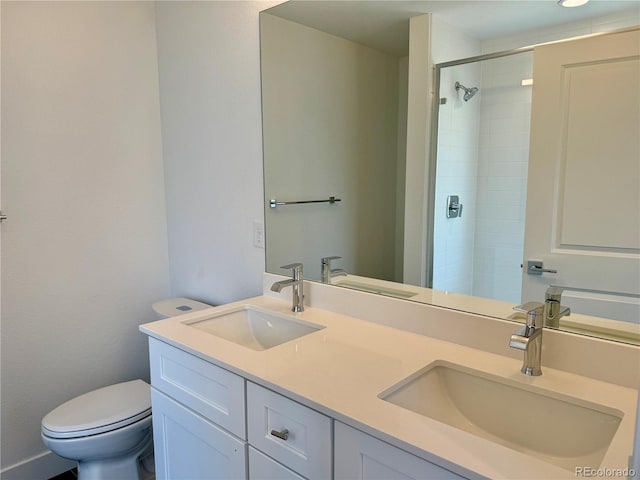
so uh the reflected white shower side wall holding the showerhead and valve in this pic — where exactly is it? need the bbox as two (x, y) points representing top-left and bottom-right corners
(431, 15), (482, 295)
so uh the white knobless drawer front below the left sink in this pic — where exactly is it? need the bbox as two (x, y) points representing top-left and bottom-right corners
(149, 338), (247, 439)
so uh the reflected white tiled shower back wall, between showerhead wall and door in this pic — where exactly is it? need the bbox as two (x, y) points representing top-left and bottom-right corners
(472, 52), (533, 303)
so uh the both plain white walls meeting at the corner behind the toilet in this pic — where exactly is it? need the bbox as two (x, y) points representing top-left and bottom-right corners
(2, 2), (270, 479)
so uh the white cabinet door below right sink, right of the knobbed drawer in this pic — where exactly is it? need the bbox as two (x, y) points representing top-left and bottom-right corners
(334, 422), (463, 480)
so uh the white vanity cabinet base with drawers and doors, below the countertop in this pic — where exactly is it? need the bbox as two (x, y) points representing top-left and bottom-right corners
(149, 338), (463, 480)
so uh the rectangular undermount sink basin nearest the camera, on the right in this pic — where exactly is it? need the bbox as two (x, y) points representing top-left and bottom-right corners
(379, 361), (623, 472)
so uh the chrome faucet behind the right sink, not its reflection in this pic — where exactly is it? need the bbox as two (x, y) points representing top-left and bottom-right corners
(509, 302), (545, 376)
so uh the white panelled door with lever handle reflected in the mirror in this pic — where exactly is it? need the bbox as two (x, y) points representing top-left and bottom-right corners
(522, 29), (640, 323)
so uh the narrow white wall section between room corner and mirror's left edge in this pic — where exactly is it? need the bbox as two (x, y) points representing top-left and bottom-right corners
(156, 1), (271, 304)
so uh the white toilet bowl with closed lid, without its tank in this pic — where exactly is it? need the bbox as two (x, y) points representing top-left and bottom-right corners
(42, 380), (153, 480)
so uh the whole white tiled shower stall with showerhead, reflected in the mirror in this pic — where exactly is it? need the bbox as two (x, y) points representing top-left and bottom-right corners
(430, 49), (533, 303)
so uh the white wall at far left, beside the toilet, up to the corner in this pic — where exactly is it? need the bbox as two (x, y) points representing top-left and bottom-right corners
(1, 1), (169, 479)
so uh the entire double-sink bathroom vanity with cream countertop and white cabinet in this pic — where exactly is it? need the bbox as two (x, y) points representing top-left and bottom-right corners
(141, 276), (640, 479)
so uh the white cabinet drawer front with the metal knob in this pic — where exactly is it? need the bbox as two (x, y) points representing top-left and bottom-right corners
(247, 382), (333, 480)
